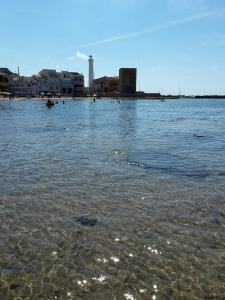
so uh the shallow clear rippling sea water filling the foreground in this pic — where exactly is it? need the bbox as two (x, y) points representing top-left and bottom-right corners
(0, 100), (225, 300)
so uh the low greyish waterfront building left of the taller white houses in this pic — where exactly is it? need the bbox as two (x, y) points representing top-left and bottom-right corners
(9, 75), (39, 97)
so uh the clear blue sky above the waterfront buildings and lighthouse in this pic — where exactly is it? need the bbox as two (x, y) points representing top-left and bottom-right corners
(0, 0), (225, 94)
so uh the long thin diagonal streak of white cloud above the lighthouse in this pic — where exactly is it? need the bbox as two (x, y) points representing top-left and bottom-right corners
(81, 10), (225, 47)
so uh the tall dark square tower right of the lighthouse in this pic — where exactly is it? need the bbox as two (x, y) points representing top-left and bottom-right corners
(119, 68), (137, 96)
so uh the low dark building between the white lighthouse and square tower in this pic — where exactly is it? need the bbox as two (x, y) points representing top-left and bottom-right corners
(93, 76), (119, 96)
